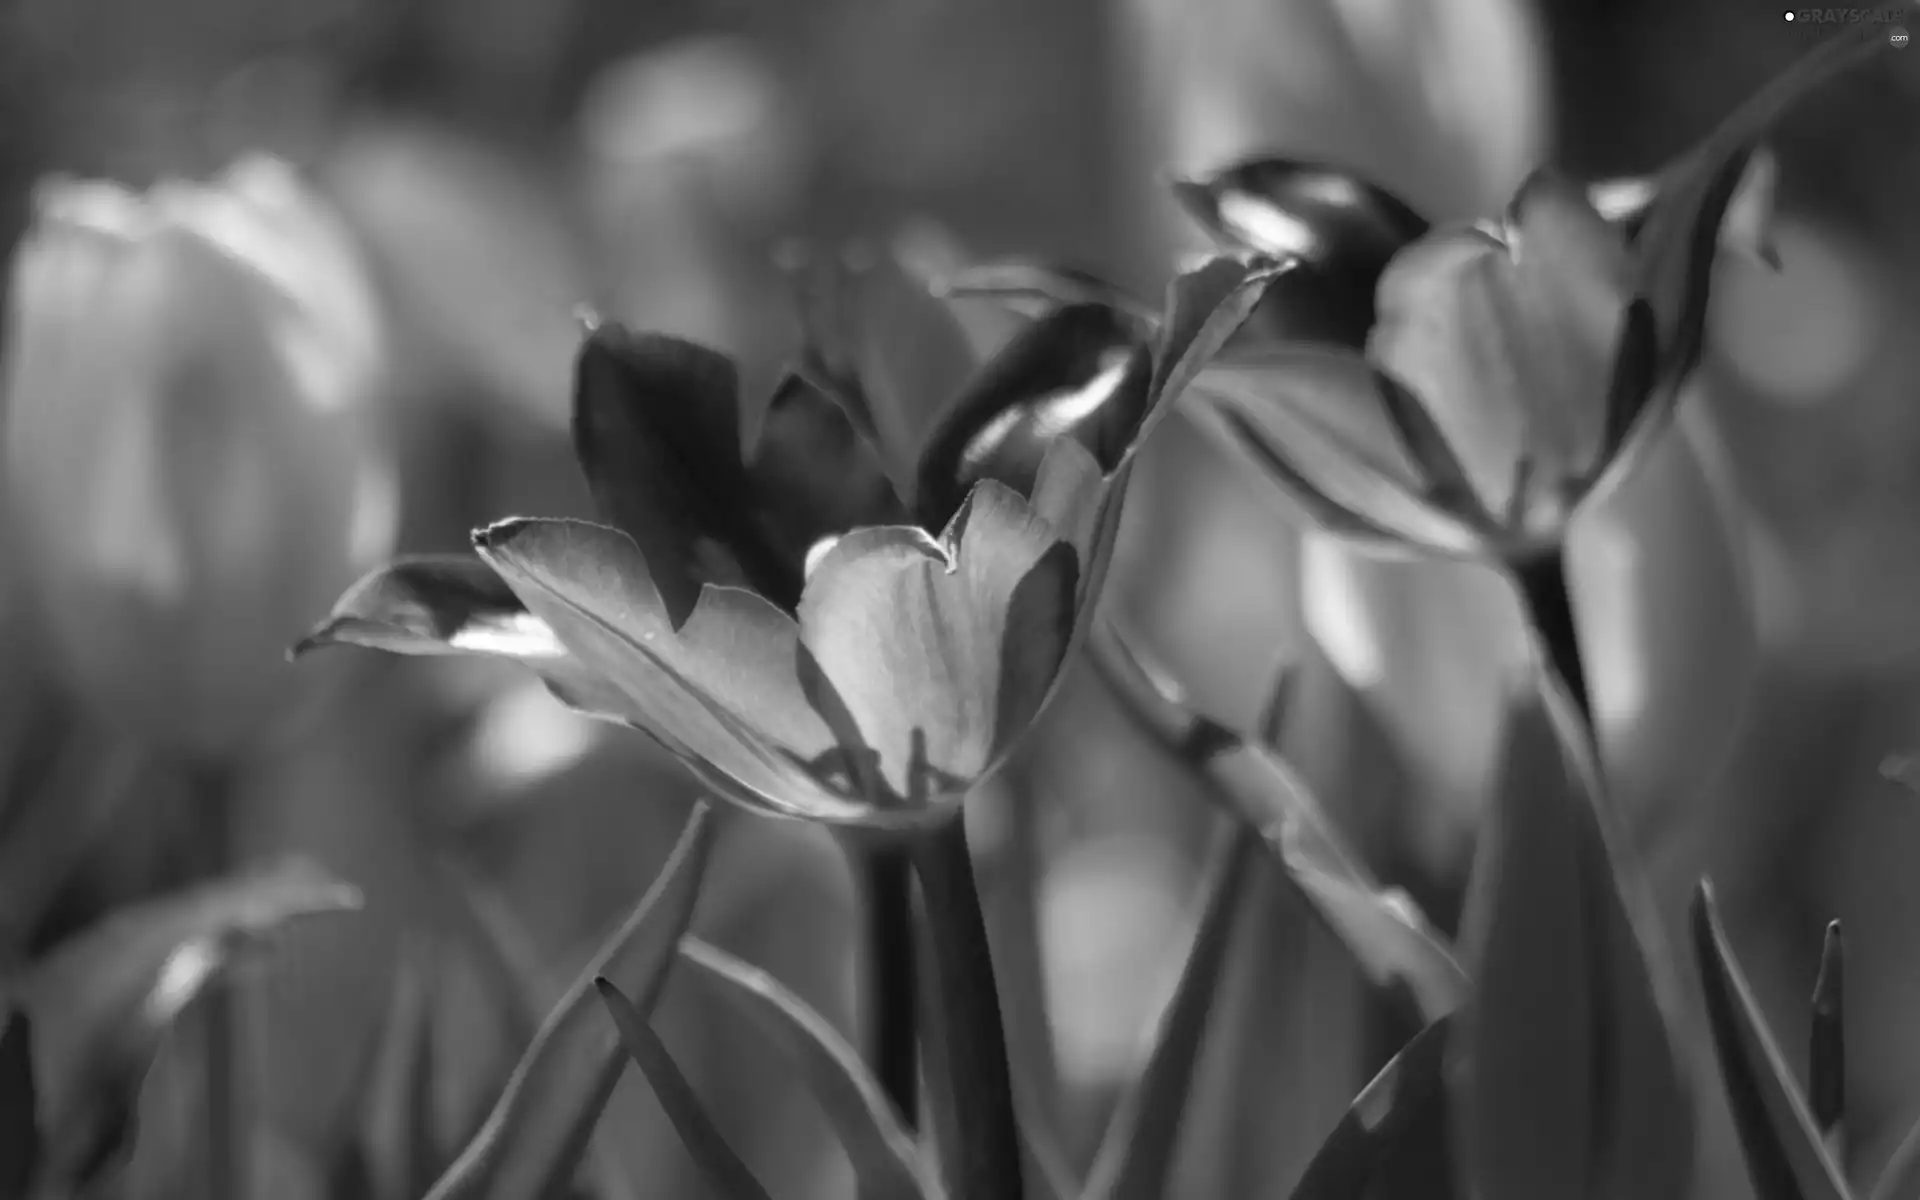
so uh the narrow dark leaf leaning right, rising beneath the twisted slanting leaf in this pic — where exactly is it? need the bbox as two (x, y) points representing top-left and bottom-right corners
(1081, 822), (1260, 1200)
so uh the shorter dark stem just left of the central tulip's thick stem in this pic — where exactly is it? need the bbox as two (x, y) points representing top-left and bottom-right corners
(847, 843), (920, 1129)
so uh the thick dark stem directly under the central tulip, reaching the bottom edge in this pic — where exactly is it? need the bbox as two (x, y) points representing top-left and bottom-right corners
(914, 814), (1023, 1200)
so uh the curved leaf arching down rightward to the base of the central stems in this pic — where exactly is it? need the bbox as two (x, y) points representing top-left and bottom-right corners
(680, 937), (943, 1200)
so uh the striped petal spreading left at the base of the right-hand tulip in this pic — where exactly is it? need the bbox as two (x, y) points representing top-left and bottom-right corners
(1188, 346), (1484, 557)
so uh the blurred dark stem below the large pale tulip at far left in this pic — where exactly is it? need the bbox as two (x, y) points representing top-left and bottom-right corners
(190, 764), (252, 1200)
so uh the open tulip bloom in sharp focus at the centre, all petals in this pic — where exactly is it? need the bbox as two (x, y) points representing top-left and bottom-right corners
(296, 257), (1273, 829)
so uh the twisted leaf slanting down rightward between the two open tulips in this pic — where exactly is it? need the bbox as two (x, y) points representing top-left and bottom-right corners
(1089, 620), (1467, 1021)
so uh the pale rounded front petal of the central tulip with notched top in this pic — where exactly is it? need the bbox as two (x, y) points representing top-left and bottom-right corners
(799, 482), (1079, 797)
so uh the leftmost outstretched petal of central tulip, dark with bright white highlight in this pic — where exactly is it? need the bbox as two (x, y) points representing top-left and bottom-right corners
(292, 555), (636, 722)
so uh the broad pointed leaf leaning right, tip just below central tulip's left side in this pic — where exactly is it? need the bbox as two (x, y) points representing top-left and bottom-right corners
(428, 804), (714, 1200)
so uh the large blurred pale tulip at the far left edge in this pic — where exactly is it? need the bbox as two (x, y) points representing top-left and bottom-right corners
(4, 159), (397, 755)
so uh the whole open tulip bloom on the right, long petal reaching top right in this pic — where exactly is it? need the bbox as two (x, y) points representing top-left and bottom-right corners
(1177, 26), (1868, 563)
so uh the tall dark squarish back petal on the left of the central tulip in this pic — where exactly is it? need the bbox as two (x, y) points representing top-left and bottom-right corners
(574, 323), (806, 626)
